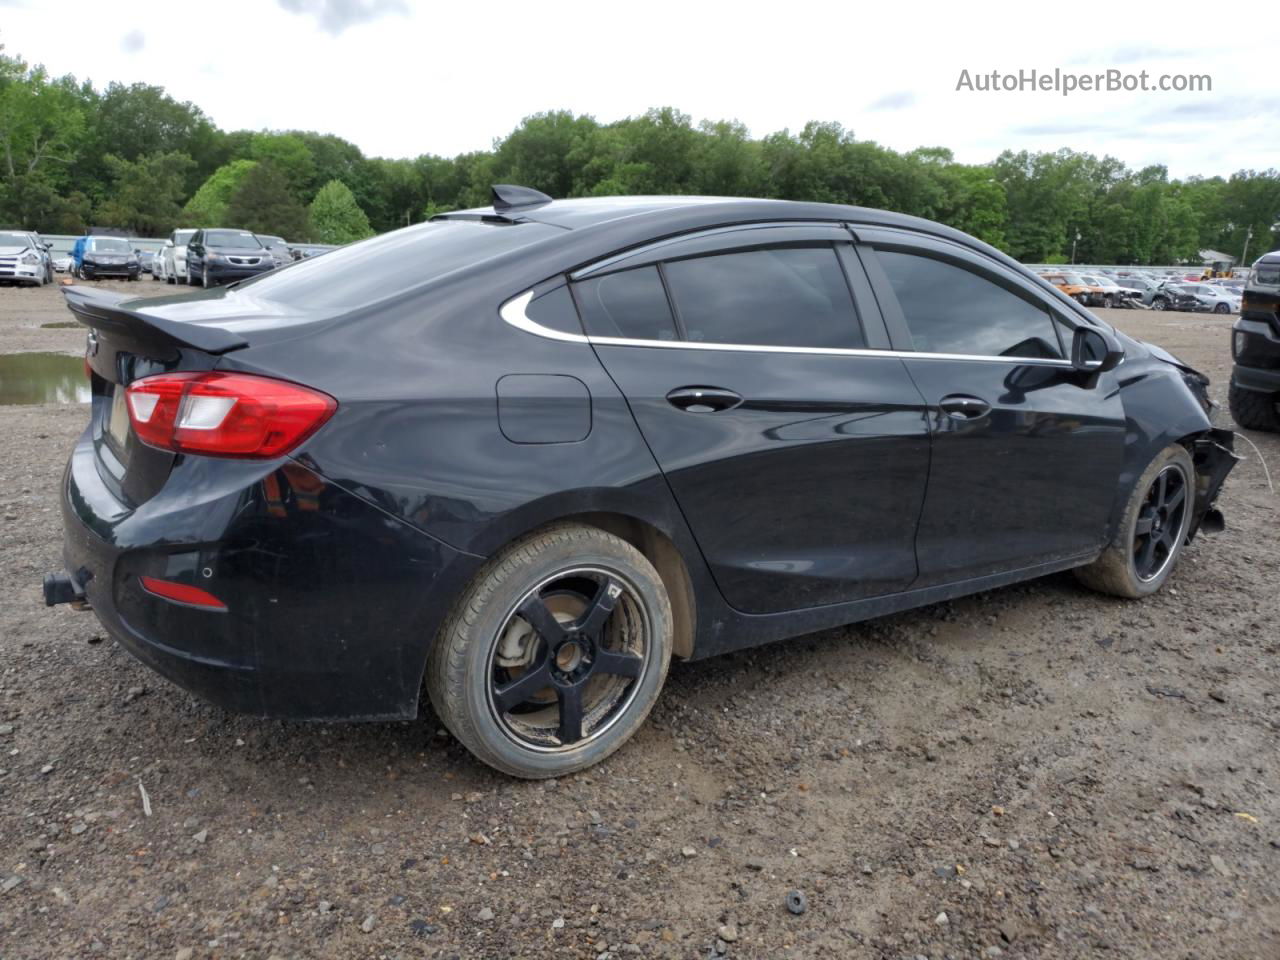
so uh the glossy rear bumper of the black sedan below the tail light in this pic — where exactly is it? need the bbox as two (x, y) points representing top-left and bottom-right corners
(61, 431), (483, 719)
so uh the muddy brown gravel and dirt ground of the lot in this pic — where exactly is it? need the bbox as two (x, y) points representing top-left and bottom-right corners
(0, 283), (1280, 960)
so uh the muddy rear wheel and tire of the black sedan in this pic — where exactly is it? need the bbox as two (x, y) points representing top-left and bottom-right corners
(426, 524), (672, 780)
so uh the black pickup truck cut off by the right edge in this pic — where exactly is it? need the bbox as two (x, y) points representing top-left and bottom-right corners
(1229, 251), (1280, 431)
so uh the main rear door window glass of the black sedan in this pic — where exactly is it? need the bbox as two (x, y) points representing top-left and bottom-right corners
(663, 244), (867, 349)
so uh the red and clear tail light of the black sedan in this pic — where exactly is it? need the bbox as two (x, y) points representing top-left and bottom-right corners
(125, 372), (338, 458)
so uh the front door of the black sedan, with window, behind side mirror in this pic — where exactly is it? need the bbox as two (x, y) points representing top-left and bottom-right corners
(858, 229), (1125, 588)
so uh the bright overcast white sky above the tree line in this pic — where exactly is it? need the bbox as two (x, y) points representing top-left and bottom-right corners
(0, 0), (1280, 177)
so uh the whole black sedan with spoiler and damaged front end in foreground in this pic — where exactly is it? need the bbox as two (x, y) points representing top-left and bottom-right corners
(45, 187), (1234, 777)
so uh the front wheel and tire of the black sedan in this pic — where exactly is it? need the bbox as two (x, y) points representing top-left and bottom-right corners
(1075, 443), (1196, 599)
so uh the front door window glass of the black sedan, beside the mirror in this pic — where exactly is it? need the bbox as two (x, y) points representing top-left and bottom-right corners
(877, 250), (1062, 360)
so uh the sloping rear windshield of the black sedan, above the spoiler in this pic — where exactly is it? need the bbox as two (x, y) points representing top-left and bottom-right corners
(237, 220), (563, 310)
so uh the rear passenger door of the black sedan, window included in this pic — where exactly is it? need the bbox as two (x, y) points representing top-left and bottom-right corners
(572, 224), (929, 613)
